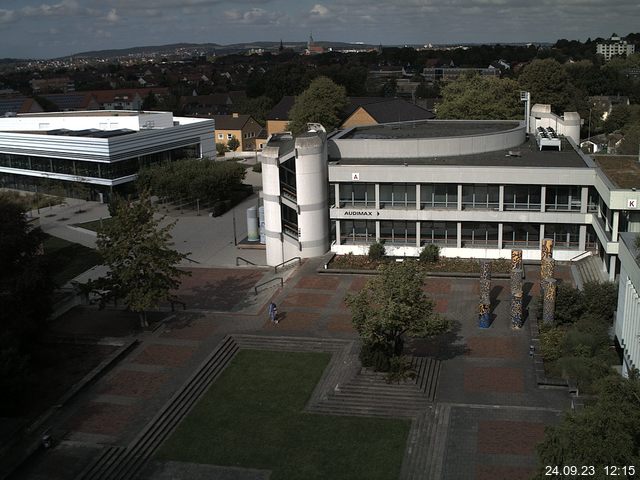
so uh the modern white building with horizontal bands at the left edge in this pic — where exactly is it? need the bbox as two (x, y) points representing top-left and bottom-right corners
(0, 110), (216, 200)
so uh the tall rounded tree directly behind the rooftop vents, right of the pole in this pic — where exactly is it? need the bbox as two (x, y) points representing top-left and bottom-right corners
(518, 58), (586, 114)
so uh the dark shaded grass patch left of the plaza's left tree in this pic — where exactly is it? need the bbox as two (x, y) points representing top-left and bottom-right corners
(44, 235), (100, 286)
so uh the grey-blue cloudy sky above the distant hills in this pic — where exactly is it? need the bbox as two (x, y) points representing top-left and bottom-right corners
(0, 0), (640, 58)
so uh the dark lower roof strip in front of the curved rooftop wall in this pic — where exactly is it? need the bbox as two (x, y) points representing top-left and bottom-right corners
(329, 137), (590, 168)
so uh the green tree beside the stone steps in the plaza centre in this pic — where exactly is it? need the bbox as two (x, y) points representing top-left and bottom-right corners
(346, 261), (449, 357)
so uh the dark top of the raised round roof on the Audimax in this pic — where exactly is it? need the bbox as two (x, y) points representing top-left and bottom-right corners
(335, 120), (521, 140)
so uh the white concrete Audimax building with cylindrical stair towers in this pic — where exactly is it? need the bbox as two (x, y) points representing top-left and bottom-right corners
(263, 105), (640, 279)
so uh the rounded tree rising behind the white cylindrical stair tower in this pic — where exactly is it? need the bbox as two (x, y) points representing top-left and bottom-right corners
(289, 77), (347, 133)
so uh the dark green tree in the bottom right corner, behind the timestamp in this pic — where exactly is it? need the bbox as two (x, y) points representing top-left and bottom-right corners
(537, 375), (640, 478)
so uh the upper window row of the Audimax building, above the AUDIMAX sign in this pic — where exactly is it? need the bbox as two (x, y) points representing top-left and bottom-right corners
(329, 183), (599, 212)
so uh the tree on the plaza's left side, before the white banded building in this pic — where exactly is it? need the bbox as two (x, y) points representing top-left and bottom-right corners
(90, 193), (189, 327)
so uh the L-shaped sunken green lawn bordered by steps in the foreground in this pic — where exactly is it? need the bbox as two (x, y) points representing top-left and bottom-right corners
(157, 350), (410, 480)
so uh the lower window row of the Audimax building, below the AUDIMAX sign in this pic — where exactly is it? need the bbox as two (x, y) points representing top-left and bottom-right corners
(339, 220), (596, 249)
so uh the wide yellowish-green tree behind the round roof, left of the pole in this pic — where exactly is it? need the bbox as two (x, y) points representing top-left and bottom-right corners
(437, 75), (524, 120)
